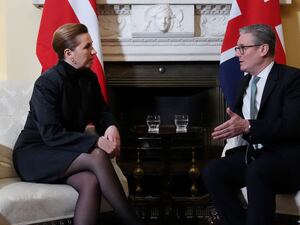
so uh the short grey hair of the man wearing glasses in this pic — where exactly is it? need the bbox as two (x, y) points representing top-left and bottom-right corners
(239, 24), (276, 57)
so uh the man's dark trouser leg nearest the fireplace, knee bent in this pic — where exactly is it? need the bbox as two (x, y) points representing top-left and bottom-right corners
(202, 149), (246, 225)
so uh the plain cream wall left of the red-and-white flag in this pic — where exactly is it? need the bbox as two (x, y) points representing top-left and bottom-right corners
(0, 0), (42, 80)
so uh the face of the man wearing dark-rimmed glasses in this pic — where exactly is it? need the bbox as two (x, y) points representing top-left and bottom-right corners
(235, 33), (262, 75)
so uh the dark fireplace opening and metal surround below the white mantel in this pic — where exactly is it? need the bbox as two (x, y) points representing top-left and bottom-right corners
(105, 62), (224, 199)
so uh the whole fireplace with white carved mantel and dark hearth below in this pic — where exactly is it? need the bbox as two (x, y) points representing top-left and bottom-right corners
(99, 0), (230, 221)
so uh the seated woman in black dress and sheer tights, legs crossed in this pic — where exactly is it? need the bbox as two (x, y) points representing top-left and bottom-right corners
(13, 24), (142, 225)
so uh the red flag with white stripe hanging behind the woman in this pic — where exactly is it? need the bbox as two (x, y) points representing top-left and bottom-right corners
(36, 0), (108, 101)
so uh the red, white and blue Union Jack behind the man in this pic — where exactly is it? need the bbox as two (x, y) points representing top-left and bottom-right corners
(219, 0), (285, 107)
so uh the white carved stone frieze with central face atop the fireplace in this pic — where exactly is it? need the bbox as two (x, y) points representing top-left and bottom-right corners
(98, 4), (231, 39)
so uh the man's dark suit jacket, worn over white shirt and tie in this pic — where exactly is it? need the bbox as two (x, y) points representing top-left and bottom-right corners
(233, 63), (300, 162)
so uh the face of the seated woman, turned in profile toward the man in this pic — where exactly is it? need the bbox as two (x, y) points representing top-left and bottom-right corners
(71, 33), (97, 69)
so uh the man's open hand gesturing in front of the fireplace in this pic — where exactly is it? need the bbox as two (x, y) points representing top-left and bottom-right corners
(211, 108), (250, 140)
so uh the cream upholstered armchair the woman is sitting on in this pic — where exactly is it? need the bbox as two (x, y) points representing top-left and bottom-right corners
(0, 81), (128, 225)
